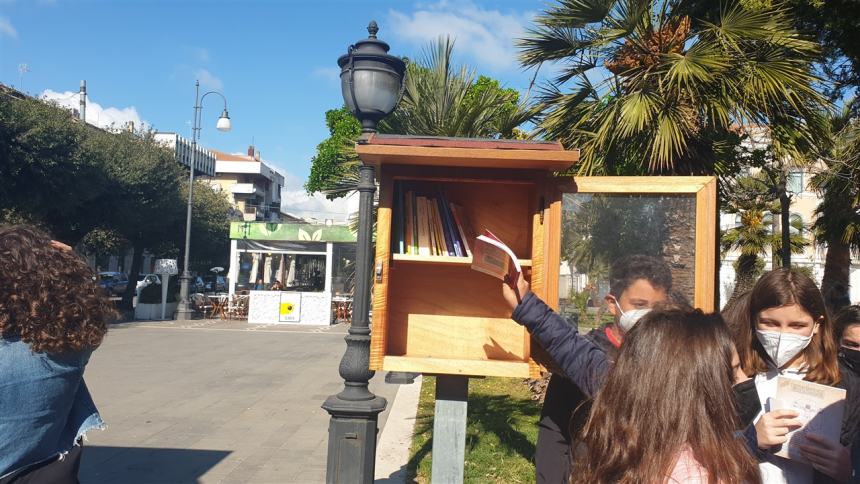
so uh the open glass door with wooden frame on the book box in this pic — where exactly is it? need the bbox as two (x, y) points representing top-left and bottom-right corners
(547, 176), (717, 327)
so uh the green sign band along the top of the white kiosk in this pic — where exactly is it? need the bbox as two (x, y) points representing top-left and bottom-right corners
(230, 222), (355, 242)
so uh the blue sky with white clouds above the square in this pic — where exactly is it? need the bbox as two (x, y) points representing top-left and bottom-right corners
(0, 0), (544, 218)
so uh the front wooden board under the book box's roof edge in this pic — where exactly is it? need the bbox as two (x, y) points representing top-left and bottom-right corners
(355, 144), (579, 171)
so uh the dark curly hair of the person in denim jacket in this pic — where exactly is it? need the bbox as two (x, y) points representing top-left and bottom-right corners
(0, 225), (116, 354)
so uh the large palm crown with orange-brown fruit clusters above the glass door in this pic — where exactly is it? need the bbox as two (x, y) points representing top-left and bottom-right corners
(519, 0), (825, 174)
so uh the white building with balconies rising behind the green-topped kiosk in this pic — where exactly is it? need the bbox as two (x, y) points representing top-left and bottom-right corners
(210, 146), (284, 222)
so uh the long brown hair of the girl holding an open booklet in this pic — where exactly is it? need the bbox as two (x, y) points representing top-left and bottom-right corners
(735, 268), (840, 385)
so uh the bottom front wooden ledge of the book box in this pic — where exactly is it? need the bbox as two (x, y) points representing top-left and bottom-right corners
(382, 356), (529, 378)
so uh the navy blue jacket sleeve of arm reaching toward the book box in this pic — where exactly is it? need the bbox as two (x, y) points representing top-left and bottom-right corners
(511, 292), (609, 396)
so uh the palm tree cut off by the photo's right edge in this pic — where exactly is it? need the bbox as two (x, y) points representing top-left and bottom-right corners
(811, 101), (860, 310)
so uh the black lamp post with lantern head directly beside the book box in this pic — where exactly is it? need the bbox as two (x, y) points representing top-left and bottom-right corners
(322, 22), (406, 484)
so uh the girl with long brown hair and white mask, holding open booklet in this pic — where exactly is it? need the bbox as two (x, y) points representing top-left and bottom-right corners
(733, 269), (851, 484)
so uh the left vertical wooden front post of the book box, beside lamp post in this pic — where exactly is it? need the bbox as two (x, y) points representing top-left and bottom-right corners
(370, 169), (394, 370)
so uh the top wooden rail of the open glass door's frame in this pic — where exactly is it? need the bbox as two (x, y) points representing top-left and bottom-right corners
(572, 176), (714, 193)
